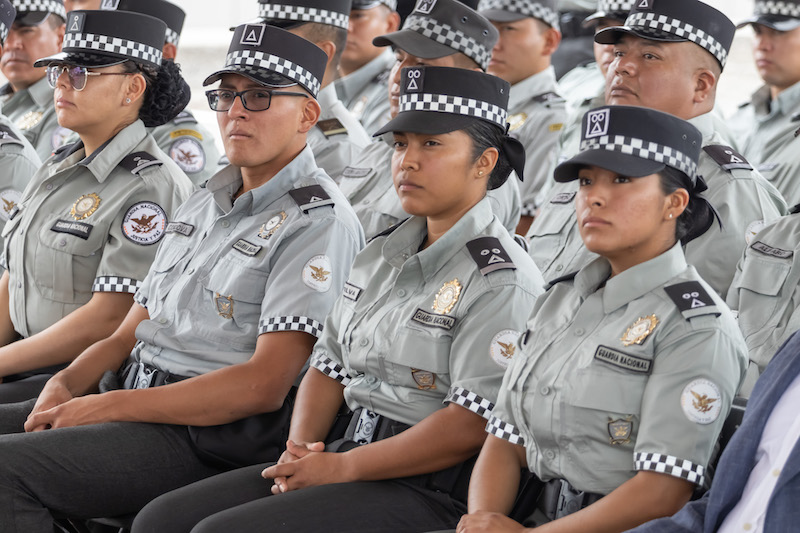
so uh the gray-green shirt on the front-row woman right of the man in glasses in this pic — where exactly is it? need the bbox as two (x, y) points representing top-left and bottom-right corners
(311, 199), (543, 424)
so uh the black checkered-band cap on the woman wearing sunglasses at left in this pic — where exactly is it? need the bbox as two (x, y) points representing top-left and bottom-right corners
(33, 11), (167, 68)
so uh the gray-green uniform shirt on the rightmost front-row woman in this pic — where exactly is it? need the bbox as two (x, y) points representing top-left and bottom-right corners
(487, 245), (747, 494)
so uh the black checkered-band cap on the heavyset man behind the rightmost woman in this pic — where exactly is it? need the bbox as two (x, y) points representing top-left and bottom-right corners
(594, 0), (736, 68)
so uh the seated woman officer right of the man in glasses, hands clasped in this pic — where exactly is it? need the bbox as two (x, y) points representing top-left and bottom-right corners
(134, 67), (542, 533)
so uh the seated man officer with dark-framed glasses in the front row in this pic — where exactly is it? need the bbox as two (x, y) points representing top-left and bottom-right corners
(0, 22), (364, 533)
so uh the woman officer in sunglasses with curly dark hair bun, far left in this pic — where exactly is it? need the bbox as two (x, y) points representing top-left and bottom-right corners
(0, 11), (192, 403)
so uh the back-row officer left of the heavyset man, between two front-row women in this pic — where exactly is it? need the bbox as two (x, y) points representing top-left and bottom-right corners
(478, 0), (567, 235)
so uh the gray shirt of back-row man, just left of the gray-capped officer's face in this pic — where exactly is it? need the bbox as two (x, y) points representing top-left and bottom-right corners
(334, 48), (395, 135)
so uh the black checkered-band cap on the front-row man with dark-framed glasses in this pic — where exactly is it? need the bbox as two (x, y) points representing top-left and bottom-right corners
(203, 23), (328, 98)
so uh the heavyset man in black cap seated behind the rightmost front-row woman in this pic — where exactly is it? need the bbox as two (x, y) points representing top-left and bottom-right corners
(529, 0), (786, 297)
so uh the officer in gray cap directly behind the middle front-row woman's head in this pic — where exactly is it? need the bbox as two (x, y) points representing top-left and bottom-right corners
(339, 0), (520, 238)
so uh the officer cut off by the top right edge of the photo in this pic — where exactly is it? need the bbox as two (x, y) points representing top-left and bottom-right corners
(730, 0), (800, 205)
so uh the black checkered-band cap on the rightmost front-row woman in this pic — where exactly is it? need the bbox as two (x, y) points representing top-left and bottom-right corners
(554, 106), (703, 186)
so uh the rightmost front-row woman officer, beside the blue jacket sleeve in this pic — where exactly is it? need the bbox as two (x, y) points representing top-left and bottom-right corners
(457, 106), (746, 532)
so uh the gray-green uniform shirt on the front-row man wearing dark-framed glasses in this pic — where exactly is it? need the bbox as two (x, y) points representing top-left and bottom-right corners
(134, 147), (364, 376)
